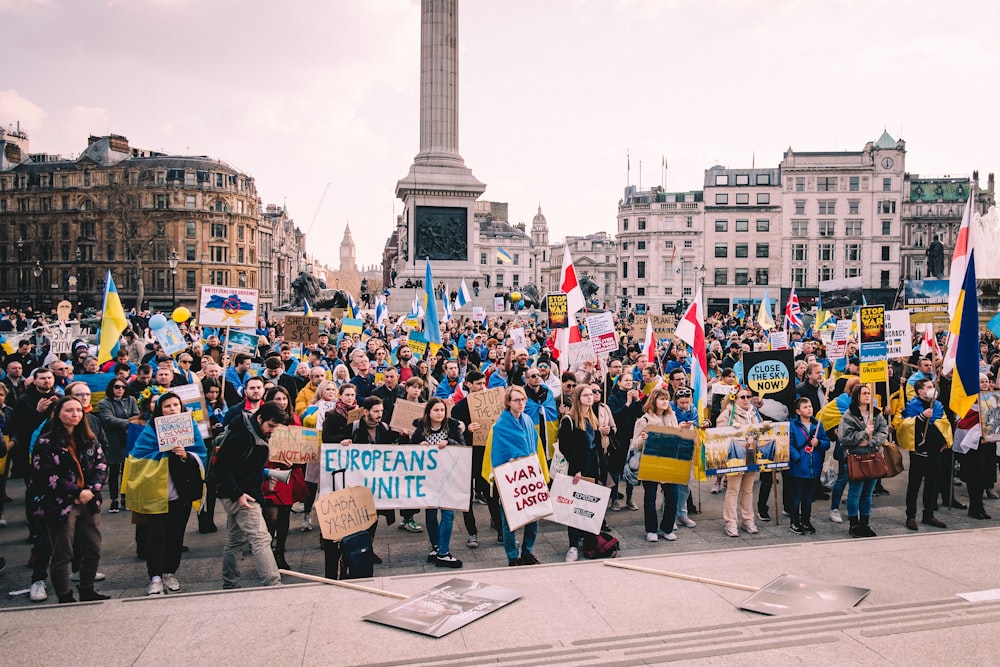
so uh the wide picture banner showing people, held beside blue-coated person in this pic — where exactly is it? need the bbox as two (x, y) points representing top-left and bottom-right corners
(704, 422), (788, 477)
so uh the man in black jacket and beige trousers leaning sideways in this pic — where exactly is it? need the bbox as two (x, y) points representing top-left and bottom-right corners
(213, 401), (288, 588)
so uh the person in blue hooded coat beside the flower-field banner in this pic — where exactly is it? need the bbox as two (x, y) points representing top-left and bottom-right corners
(788, 397), (830, 535)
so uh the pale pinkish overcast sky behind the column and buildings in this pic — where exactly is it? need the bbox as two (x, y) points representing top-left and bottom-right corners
(0, 0), (1000, 268)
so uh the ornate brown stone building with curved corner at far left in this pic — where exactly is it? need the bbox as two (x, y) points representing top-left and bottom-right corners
(0, 130), (260, 309)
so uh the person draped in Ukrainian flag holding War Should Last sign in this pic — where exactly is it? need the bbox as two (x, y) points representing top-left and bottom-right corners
(482, 385), (549, 566)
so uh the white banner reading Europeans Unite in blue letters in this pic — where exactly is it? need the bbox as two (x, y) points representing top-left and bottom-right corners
(319, 444), (472, 511)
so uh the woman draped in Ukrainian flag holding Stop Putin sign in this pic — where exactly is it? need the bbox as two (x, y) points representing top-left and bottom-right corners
(125, 392), (207, 595)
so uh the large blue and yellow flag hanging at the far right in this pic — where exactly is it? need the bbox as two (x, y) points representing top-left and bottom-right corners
(948, 250), (979, 417)
